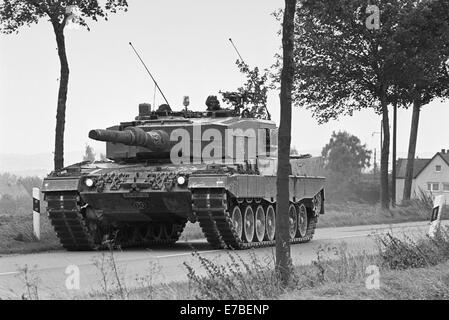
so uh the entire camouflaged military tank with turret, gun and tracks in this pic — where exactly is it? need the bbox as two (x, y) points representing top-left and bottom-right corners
(42, 99), (325, 251)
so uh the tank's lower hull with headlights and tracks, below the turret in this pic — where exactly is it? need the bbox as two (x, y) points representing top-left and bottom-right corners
(43, 163), (325, 250)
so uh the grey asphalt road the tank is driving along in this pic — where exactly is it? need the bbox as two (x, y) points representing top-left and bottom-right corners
(0, 221), (440, 299)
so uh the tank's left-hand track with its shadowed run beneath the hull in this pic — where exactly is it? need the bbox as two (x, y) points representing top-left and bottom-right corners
(46, 192), (186, 251)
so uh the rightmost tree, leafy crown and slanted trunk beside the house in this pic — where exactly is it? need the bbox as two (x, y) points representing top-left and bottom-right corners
(395, 1), (449, 201)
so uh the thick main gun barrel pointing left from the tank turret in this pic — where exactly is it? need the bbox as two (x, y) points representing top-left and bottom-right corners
(89, 127), (170, 151)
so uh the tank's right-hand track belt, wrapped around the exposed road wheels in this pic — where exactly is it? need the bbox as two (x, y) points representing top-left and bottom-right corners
(192, 188), (318, 250)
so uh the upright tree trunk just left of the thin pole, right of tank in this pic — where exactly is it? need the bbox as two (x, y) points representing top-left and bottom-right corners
(380, 90), (390, 210)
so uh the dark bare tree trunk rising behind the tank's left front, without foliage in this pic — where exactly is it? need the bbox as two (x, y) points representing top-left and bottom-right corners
(53, 22), (69, 170)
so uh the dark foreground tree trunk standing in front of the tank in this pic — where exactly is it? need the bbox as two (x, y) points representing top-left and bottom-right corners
(276, 0), (296, 285)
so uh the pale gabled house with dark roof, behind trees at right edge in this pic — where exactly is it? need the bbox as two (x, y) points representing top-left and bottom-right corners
(396, 149), (449, 203)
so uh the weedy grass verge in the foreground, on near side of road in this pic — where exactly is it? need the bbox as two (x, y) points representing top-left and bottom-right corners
(82, 228), (449, 300)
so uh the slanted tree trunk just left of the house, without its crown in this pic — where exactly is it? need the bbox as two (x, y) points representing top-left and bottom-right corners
(402, 95), (421, 201)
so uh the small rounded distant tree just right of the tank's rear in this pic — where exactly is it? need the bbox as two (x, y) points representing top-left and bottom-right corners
(321, 131), (371, 178)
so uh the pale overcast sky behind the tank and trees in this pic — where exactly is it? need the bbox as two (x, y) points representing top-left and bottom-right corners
(0, 0), (449, 170)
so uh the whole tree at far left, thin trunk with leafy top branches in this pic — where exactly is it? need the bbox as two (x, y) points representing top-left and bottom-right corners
(0, 0), (128, 170)
